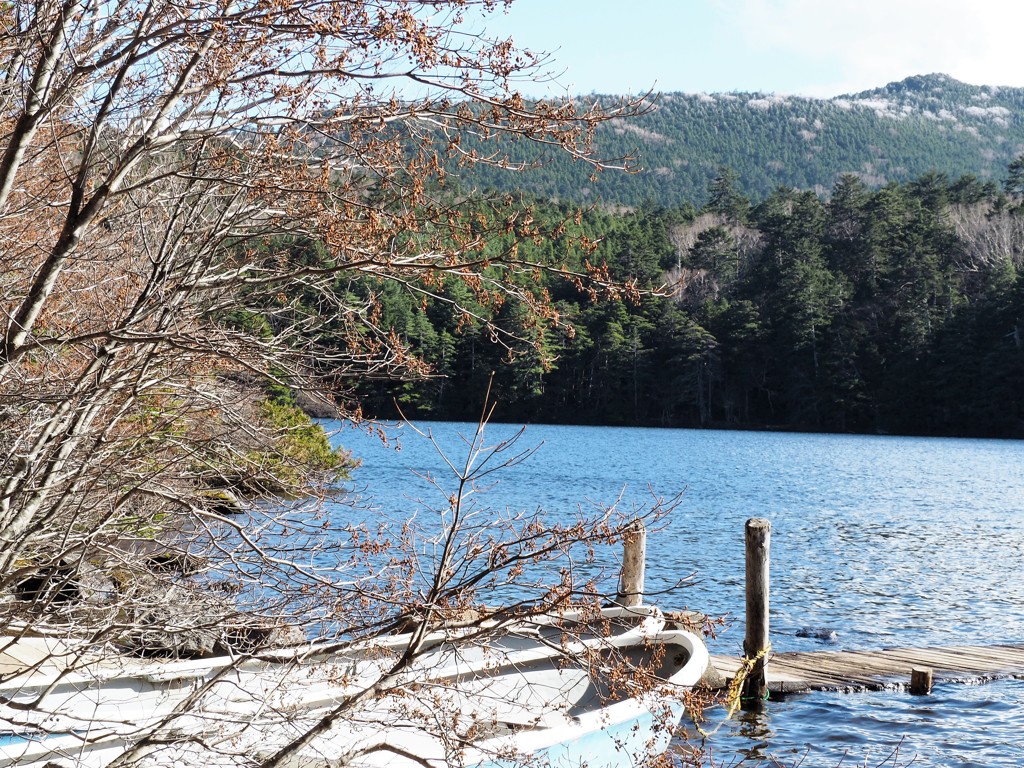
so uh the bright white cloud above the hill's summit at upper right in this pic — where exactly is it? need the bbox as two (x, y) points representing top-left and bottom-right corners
(718, 0), (1024, 96)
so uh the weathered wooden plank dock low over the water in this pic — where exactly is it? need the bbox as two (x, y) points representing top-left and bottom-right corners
(709, 643), (1024, 693)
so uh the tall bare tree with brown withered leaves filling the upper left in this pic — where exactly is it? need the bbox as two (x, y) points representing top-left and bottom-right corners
(0, 0), (638, 589)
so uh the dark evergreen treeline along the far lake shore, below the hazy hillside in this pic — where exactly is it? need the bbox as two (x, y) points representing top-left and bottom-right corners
(345, 161), (1024, 437)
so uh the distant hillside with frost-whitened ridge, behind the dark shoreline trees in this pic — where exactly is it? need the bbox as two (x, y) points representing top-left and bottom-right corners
(461, 75), (1024, 207)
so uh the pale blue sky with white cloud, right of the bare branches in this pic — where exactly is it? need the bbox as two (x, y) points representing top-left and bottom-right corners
(473, 0), (1024, 96)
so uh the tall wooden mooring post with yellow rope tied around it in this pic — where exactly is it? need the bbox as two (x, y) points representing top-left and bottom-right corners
(740, 517), (771, 709)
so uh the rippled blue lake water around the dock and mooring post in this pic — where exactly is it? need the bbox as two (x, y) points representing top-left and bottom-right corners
(325, 423), (1024, 768)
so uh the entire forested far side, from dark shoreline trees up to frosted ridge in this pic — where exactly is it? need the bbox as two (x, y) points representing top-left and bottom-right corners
(273, 75), (1024, 437)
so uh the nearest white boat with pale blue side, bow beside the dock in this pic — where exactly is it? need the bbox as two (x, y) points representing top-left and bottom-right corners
(278, 630), (709, 768)
